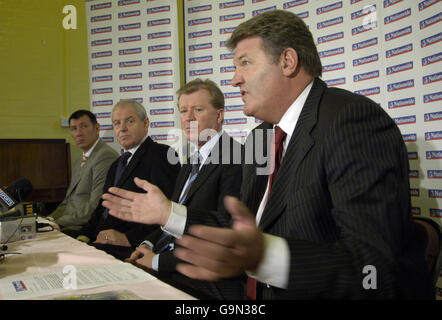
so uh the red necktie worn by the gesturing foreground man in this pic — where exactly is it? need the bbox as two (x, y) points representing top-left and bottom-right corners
(247, 126), (287, 300)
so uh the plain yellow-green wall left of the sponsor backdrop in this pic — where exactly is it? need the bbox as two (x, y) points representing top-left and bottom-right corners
(0, 0), (90, 159)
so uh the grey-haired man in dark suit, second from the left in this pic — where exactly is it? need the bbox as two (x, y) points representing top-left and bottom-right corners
(77, 100), (180, 259)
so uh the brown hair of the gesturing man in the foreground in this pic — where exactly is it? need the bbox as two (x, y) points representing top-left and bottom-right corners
(227, 10), (322, 77)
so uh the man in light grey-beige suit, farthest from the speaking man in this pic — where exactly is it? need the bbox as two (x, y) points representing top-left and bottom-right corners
(48, 110), (118, 237)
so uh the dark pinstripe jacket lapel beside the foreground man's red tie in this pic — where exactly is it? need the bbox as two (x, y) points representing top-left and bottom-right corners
(259, 79), (326, 230)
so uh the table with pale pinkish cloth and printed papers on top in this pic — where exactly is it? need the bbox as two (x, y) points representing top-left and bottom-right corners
(0, 218), (194, 300)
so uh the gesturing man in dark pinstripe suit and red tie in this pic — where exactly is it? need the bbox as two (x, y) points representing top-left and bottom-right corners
(175, 10), (431, 299)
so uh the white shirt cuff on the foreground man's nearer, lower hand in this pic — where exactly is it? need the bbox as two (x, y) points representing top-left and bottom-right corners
(247, 233), (290, 289)
